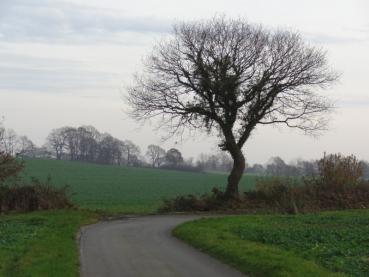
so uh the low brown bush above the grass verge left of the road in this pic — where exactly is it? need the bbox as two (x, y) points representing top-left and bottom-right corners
(0, 177), (72, 213)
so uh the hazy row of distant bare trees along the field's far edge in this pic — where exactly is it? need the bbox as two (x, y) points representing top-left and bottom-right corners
(0, 123), (369, 178)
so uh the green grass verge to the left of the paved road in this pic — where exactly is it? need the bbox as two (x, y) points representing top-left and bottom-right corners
(0, 210), (97, 277)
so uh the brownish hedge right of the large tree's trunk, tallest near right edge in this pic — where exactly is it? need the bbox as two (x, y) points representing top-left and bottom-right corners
(244, 154), (369, 213)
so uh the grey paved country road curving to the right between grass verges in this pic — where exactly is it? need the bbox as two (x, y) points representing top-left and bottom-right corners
(80, 216), (244, 277)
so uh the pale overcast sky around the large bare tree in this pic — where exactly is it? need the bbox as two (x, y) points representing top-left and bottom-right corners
(0, 0), (369, 163)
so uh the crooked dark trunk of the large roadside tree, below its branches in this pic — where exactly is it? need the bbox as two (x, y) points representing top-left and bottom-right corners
(225, 147), (246, 199)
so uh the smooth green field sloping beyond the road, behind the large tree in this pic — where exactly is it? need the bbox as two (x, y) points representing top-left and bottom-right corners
(20, 156), (256, 213)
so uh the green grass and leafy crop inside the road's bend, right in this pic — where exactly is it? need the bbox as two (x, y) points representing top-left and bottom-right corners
(174, 210), (369, 276)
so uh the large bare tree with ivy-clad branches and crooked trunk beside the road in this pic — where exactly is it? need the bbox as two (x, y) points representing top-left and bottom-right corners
(127, 17), (337, 198)
